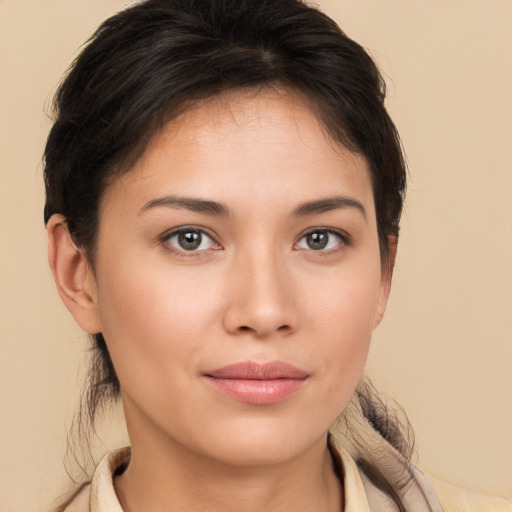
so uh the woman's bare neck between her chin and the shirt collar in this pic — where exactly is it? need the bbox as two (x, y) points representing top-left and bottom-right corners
(114, 408), (343, 512)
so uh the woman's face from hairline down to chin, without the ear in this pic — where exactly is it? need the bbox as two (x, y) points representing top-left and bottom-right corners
(86, 91), (389, 464)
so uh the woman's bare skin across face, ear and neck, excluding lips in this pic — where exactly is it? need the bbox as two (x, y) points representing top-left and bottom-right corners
(48, 90), (391, 512)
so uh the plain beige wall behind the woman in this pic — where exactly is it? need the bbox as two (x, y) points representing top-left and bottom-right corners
(0, 0), (512, 512)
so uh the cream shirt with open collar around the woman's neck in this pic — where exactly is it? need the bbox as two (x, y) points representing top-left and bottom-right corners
(66, 446), (512, 512)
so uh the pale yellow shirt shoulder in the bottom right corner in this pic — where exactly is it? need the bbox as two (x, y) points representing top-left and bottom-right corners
(423, 473), (512, 512)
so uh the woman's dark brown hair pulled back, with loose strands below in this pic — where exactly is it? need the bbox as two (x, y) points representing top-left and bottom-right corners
(44, 0), (409, 508)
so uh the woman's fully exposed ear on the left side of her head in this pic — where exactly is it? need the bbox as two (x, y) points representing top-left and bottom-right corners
(47, 214), (102, 334)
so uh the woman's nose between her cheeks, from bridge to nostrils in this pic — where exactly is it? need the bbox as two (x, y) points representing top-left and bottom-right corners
(224, 252), (298, 339)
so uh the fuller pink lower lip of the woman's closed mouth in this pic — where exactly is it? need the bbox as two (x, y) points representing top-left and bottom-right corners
(207, 377), (306, 405)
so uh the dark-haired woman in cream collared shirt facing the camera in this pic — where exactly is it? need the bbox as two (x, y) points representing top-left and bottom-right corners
(45, 0), (510, 512)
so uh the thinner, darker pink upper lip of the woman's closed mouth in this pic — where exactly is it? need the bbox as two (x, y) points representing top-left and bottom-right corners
(206, 361), (310, 380)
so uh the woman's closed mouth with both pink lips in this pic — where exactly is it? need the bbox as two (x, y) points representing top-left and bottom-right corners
(204, 361), (311, 405)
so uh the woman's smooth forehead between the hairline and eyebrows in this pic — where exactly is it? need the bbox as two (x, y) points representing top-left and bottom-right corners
(106, 89), (373, 214)
